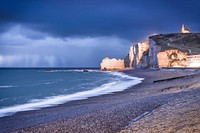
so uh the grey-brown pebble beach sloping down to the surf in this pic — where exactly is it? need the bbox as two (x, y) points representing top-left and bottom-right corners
(0, 69), (200, 133)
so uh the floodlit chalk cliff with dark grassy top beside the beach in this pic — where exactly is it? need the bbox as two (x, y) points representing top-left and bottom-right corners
(101, 33), (200, 70)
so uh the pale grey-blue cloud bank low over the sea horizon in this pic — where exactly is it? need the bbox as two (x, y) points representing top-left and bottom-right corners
(0, 26), (131, 67)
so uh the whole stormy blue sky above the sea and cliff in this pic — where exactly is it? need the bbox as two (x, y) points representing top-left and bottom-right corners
(0, 0), (200, 67)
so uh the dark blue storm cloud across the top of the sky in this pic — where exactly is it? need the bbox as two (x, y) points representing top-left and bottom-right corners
(0, 0), (200, 39)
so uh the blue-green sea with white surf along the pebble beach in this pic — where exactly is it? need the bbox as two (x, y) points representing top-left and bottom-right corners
(0, 68), (143, 117)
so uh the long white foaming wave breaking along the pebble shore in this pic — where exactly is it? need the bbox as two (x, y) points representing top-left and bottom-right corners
(0, 72), (143, 117)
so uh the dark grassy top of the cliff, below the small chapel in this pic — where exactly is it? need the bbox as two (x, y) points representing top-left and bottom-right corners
(149, 33), (200, 54)
